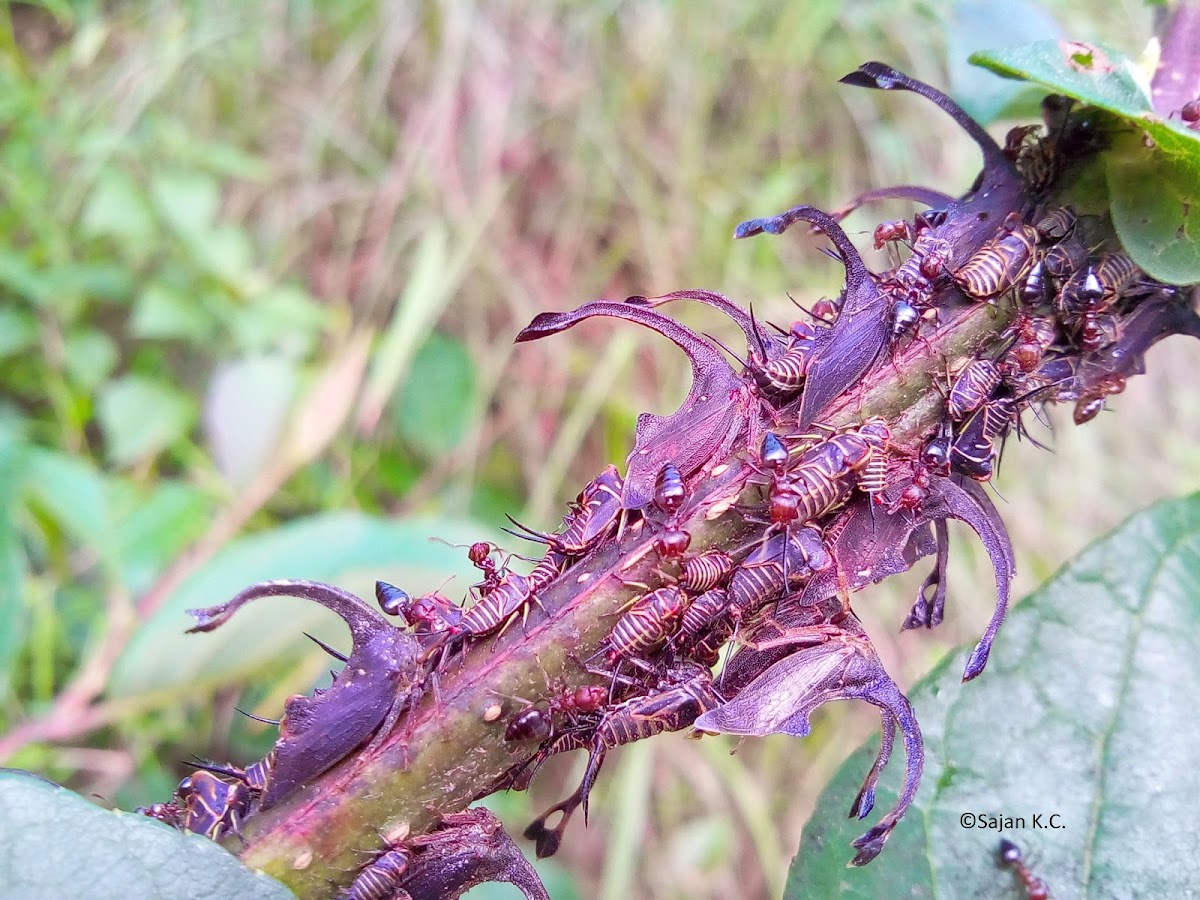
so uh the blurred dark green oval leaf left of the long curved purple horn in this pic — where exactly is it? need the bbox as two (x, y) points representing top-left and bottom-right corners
(392, 331), (475, 460)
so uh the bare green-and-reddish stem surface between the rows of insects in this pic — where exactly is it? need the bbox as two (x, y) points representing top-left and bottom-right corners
(232, 294), (1009, 898)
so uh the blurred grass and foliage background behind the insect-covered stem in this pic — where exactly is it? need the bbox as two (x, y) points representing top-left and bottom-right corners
(0, 0), (1200, 899)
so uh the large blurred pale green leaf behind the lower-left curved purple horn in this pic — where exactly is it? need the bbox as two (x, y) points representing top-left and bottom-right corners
(108, 512), (494, 697)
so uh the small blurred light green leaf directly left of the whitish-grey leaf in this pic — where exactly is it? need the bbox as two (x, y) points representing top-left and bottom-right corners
(97, 376), (196, 466)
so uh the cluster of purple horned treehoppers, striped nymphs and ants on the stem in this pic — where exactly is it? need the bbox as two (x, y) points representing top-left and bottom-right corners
(142, 62), (1200, 900)
